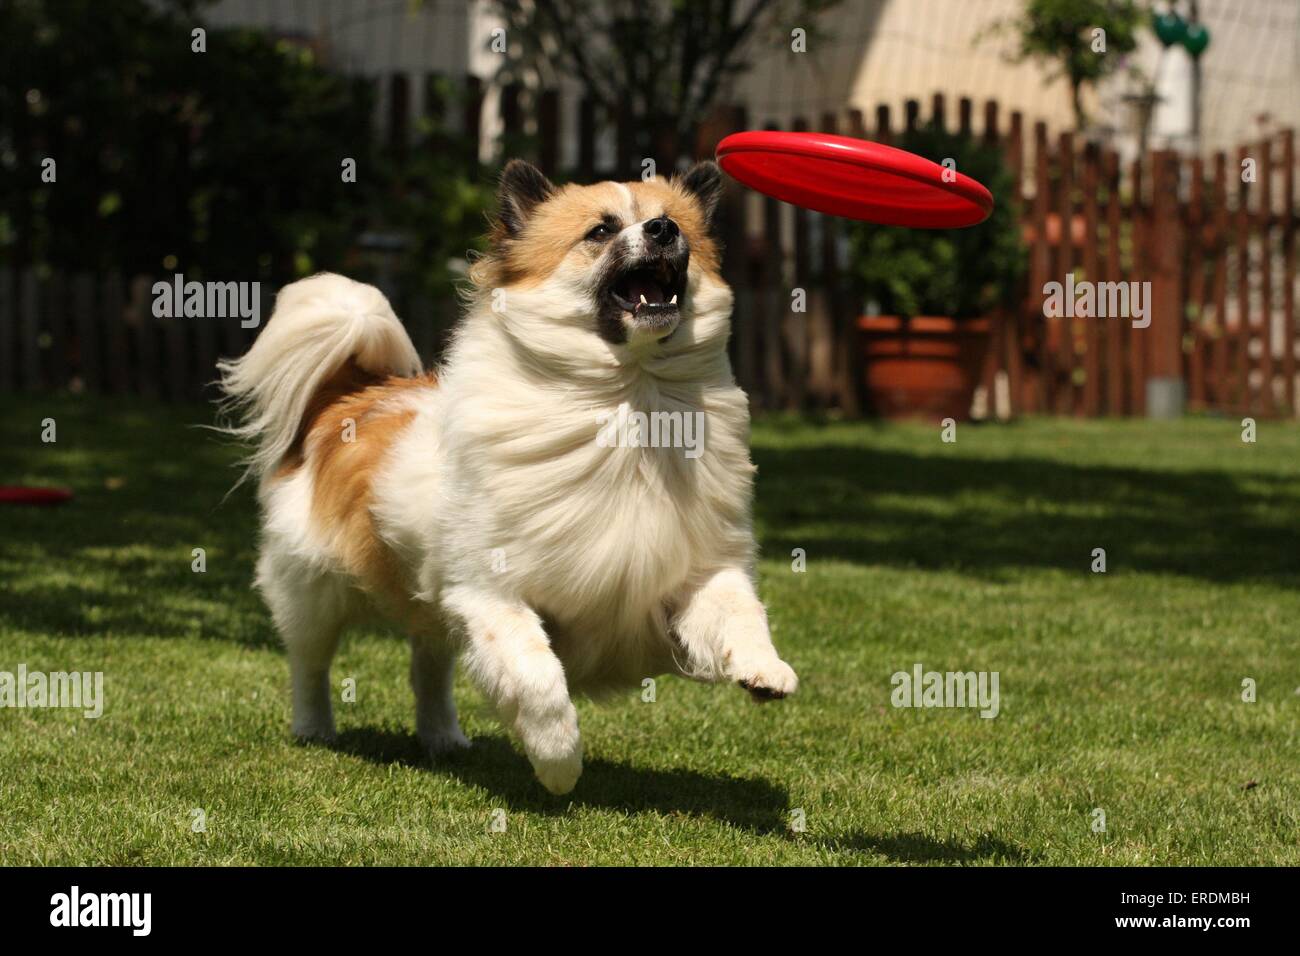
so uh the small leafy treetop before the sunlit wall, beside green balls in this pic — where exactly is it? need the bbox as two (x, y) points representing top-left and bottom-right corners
(985, 0), (1147, 130)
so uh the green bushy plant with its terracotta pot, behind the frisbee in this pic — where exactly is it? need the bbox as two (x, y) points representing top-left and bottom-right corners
(849, 125), (1026, 419)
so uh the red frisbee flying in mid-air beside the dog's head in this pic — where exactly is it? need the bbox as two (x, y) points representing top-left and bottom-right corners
(718, 130), (993, 229)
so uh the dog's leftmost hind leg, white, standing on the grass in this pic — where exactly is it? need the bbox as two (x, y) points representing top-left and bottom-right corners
(257, 553), (350, 740)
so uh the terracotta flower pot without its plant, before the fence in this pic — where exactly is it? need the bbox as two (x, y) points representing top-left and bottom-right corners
(858, 315), (989, 421)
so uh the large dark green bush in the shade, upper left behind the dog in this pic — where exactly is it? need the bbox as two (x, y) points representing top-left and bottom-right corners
(0, 0), (491, 291)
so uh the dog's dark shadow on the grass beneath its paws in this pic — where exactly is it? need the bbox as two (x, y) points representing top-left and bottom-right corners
(332, 727), (1024, 864)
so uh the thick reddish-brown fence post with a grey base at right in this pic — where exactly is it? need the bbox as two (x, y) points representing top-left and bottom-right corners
(1147, 150), (1187, 419)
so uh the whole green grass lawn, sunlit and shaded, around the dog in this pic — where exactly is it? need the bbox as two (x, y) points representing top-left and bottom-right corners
(0, 398), (1300, 865)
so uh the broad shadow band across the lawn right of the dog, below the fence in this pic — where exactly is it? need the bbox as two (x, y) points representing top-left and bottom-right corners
(754, 444), (1300, 587)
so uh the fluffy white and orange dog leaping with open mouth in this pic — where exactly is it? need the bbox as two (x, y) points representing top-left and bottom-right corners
(221, 161), (798, 793)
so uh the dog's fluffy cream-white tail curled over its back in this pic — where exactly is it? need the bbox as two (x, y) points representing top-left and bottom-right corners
(217, 272), (420, 486)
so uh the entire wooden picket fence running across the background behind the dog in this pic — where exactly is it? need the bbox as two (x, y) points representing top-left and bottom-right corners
(0, 74), (1300, 418)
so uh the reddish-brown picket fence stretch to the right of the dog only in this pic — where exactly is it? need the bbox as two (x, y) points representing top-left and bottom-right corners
(706, 95), (1300, 418)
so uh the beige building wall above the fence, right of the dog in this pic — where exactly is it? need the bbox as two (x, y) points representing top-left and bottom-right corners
(733, 0), (1300, 158)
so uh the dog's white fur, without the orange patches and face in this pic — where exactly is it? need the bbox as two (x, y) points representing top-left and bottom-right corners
(218, 221), (798, 793)
